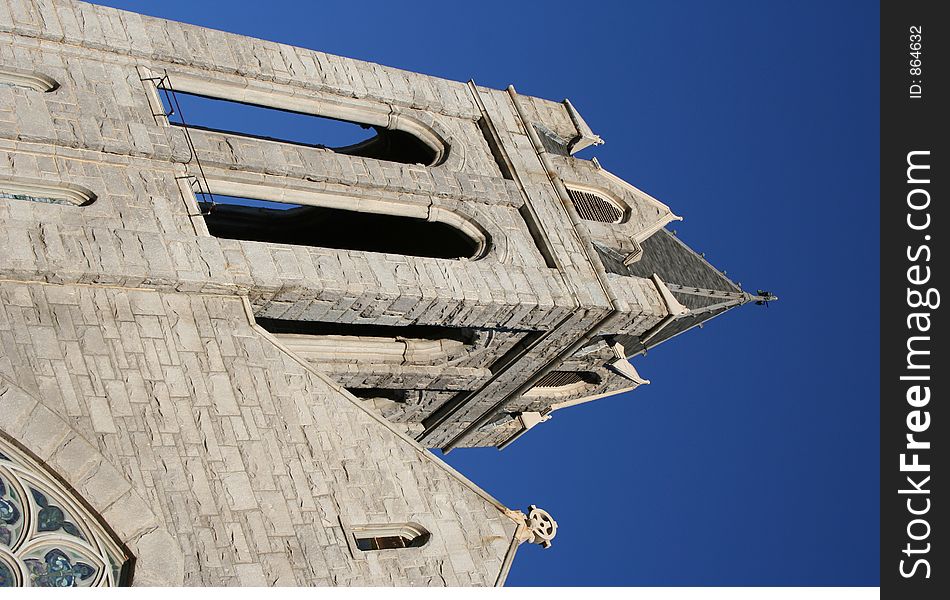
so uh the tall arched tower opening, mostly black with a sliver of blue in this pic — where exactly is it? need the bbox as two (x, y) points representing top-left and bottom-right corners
(200, 194), (482, 258)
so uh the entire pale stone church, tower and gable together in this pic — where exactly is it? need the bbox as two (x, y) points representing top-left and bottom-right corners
(0, 0), (772, 585)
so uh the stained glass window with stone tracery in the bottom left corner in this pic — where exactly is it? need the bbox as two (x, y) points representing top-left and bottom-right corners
(0, 438), (128, 587)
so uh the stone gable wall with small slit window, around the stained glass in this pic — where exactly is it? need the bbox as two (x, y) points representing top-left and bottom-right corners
(0, 282), (516, 585)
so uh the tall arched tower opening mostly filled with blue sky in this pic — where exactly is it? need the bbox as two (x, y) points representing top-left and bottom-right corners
(159, 88), (439, 165)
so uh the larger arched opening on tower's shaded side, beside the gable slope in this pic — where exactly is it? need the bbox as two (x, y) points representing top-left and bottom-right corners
(257, 319), (475, 365)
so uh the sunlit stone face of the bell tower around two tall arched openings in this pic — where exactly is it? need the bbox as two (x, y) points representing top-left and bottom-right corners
(0, 0), (680, 454)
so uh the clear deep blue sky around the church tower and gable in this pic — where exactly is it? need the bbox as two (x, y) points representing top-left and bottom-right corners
(93, 0), (879, 585)
